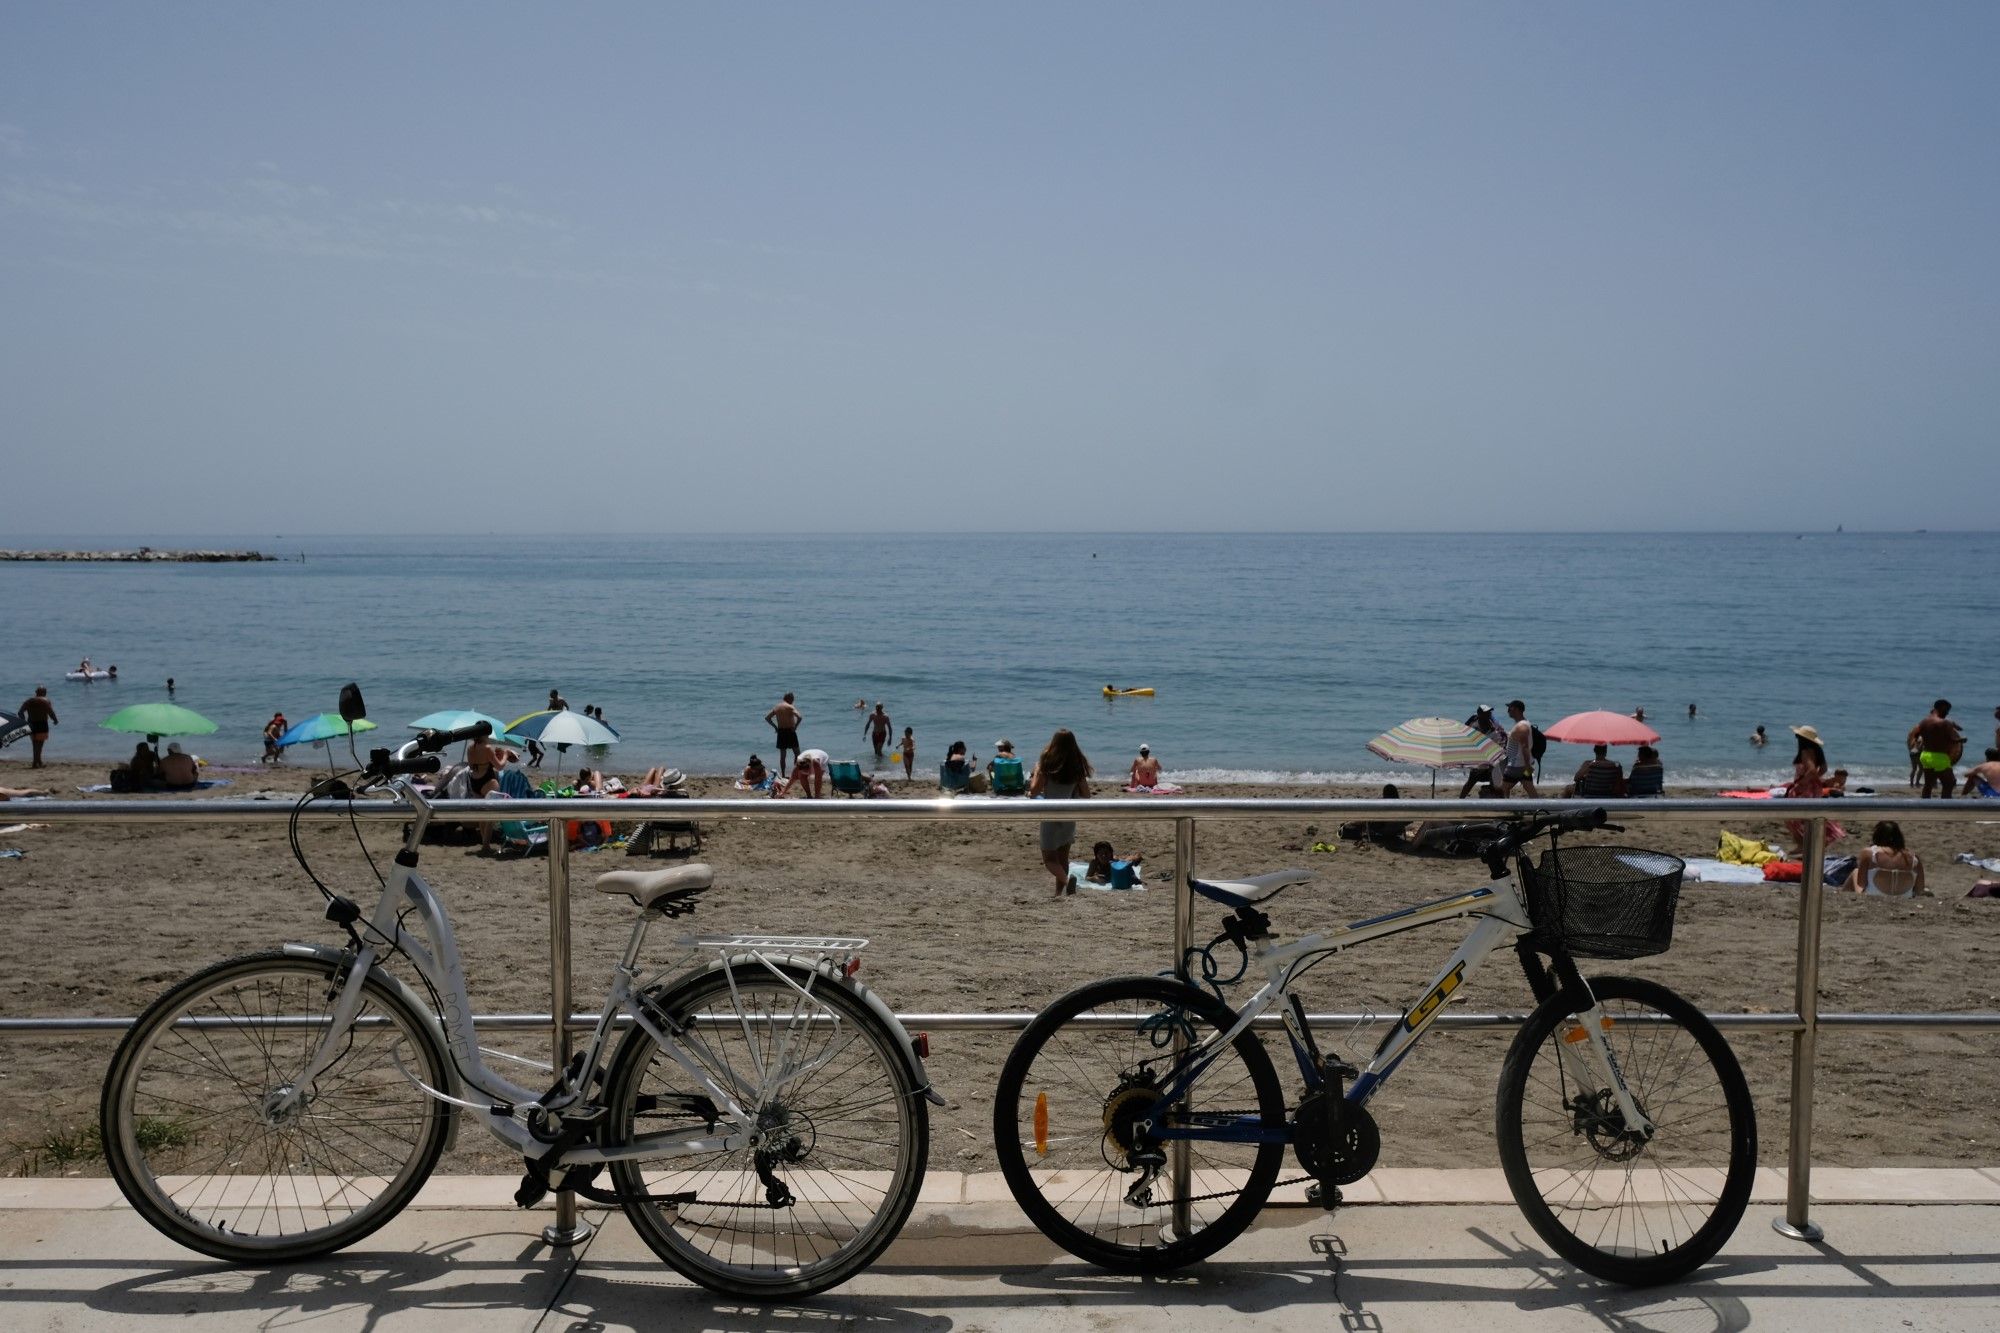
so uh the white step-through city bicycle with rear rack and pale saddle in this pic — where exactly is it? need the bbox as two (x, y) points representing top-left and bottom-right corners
(100, 687), (942, 1299)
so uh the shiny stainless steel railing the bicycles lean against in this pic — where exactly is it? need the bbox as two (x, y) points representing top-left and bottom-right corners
(0, 797), (2000, 1245)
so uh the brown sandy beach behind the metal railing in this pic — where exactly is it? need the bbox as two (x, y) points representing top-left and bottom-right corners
(0, 753), (2000, 1175)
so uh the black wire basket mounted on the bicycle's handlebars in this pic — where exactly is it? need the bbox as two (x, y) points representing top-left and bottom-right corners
(1520, 847), (1688, 959)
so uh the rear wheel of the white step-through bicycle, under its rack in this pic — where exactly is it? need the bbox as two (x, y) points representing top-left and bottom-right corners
(606, 967), (930, 1299)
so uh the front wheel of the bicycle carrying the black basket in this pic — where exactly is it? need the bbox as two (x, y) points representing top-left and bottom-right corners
(1494, 977), (1756, 1287)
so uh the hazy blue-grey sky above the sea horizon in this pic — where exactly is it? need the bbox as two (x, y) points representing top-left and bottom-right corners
(0, 0), (2000, 544)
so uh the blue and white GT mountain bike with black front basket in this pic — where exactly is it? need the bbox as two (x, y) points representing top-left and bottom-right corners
(994, 811), (1756, 1285)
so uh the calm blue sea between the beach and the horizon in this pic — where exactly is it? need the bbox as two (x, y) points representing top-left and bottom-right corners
(0, 532), (2000, 783)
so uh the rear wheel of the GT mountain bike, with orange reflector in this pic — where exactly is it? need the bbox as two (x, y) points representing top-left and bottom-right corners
(994, 977), (1286, 1273)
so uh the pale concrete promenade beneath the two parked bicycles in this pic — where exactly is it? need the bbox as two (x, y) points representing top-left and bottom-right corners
(0, 1169), (2000, 1333)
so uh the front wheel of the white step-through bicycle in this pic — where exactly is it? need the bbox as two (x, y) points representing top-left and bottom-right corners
(98, 951), (450, 1263)
